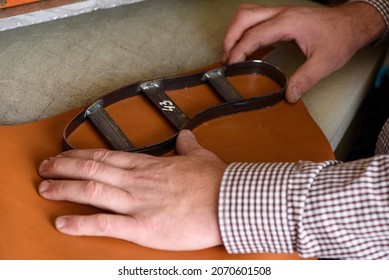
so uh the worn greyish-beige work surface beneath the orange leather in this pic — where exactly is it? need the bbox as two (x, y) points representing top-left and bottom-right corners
(0, 0), (383, 153)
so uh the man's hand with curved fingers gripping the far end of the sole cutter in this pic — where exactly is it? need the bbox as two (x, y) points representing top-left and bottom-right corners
(223, 2), (386, 103)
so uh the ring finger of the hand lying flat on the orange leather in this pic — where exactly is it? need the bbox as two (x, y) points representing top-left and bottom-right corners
(39, 180), (133, 214)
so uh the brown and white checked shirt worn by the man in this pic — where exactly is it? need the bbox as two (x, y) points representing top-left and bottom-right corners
(219, 0), (389, 259)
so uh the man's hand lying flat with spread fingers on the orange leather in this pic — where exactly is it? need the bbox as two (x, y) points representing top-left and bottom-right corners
(39, 131), (226, 250)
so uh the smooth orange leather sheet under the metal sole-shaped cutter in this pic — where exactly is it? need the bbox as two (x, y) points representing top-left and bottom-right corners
(0, 59), (334, 260)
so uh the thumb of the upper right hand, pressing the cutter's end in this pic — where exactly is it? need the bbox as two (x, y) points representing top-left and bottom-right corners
(285, 56), (331, 103)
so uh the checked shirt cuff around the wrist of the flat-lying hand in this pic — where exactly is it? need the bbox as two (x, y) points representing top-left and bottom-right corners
(218, 163), (295, 253)
